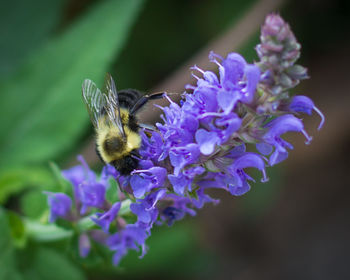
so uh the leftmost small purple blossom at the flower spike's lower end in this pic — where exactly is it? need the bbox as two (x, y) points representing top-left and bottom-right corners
(44, 192), (72, 223)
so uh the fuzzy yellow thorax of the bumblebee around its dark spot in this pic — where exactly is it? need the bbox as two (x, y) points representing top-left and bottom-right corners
(96, 108), (141, 163)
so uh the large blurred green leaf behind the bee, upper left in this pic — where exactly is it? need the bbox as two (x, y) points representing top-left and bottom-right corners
(0, 0), (143, 166)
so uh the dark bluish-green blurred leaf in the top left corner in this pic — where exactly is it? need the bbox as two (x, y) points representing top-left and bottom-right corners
(0, 0), (66, 78)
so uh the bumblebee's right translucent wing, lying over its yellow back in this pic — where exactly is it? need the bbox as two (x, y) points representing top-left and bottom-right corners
(104, 73), (126, 138)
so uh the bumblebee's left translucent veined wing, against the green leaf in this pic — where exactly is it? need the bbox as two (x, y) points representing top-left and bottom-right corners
(82, 79), (106, 128)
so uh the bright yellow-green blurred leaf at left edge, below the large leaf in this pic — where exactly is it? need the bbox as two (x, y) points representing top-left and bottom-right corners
(0, 166), (54, 204)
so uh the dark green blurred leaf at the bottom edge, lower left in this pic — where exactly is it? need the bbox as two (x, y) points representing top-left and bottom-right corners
(23, 247), (85, 280)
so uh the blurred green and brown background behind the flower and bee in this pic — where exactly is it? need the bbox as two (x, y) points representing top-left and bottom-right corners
(0, 0), (350, 280)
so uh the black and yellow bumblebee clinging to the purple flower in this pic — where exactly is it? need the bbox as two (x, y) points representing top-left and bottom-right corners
(82, 74), (164, 175)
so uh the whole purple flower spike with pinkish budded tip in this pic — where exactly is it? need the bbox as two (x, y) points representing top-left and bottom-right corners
(48, 14), (324, 265)
